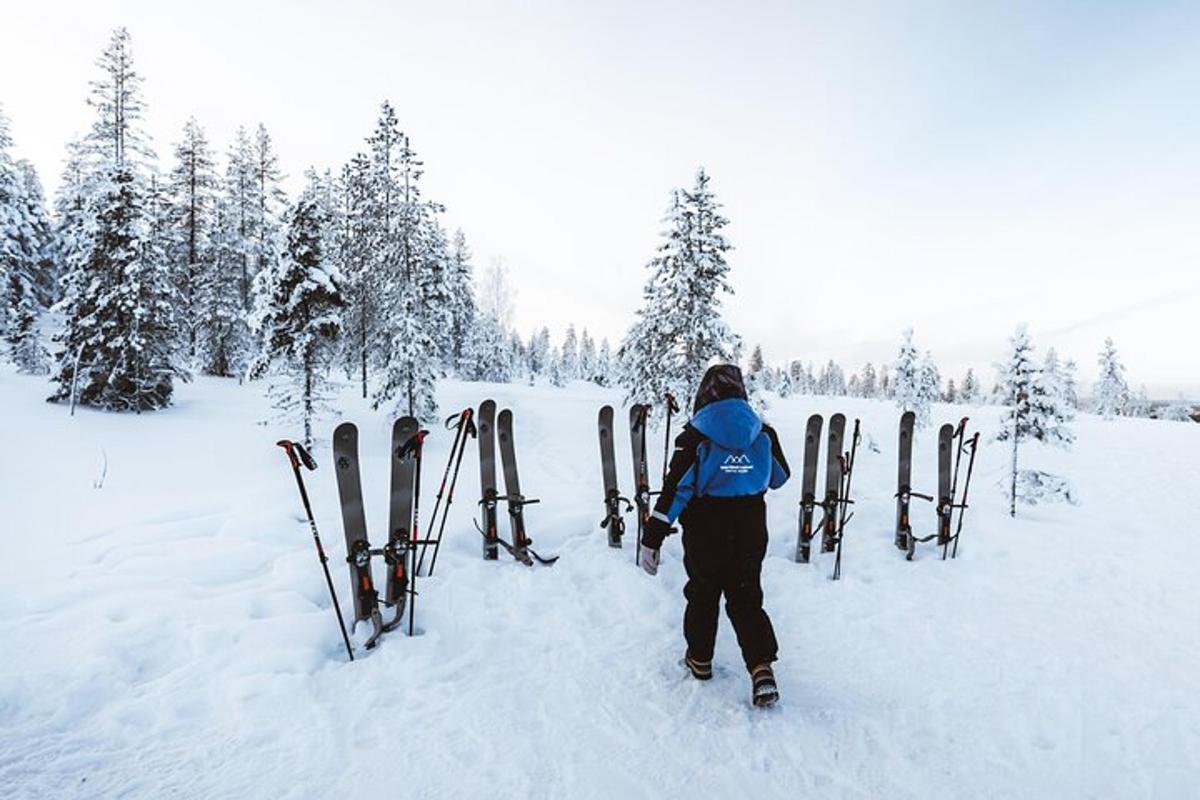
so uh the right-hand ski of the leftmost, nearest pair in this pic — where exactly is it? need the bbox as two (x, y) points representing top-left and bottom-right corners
(383, 416), (420, 630)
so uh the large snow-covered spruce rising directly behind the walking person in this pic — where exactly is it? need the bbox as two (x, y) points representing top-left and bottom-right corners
(618, 169), (739, 404)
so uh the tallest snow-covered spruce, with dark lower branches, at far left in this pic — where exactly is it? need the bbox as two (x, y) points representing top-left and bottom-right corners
(50, 29), (186, 411)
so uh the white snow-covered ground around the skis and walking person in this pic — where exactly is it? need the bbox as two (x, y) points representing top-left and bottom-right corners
(0, 372), (1200, 798)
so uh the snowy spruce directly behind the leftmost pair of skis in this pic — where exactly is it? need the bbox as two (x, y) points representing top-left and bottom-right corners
(252, 172), (346, 447)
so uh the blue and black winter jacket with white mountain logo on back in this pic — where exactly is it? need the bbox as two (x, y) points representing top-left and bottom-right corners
(653, 398), (791, 524)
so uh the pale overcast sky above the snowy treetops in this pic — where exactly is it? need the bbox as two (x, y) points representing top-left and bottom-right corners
(0, 0), (1200, 397)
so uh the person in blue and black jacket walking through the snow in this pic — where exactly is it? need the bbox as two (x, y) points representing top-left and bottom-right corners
(638, 365), (790, 705)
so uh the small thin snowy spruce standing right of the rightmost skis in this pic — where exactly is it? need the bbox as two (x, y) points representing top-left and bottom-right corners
(996, 325), (1075, 517)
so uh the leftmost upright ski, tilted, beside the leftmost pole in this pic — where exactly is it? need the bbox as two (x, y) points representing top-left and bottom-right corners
(334, 422), (383, 650)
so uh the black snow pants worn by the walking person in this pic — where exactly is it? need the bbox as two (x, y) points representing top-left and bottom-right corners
(679, 494), (779, 669)
